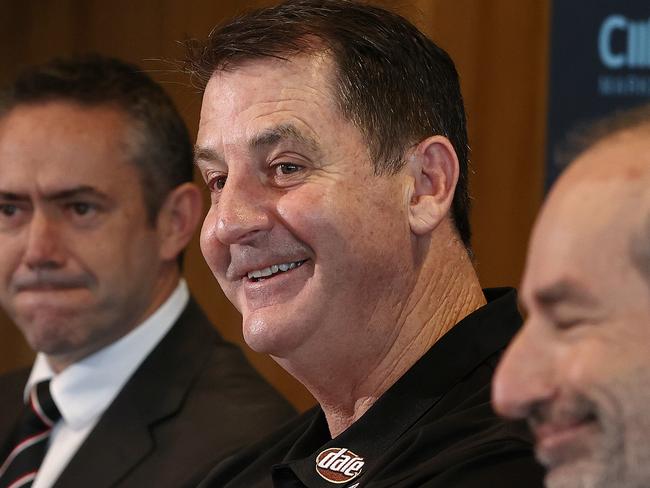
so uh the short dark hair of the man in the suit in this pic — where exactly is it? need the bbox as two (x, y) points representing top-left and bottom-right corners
(0, 54), (193, 224)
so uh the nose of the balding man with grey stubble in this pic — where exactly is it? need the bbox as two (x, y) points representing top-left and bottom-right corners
(492, 325), (554, 418)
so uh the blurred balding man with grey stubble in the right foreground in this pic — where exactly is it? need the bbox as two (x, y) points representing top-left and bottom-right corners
(494, 106), (650, 488)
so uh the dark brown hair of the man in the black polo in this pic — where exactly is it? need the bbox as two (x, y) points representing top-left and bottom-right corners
(186, 0), (471, 250)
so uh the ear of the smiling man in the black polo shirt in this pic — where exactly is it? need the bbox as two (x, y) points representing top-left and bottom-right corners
(407, 135), (459, 235)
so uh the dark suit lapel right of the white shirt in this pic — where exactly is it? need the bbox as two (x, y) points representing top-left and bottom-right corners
(53, 300), (218, 488)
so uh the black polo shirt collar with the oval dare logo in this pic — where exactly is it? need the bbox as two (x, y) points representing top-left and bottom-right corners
(273, 288), (521, 488)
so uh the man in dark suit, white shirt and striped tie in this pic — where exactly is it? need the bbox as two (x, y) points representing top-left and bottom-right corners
(0, 56), (293, 488)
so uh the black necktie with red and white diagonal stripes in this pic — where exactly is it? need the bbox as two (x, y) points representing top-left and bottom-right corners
(0, 380), (61, 488)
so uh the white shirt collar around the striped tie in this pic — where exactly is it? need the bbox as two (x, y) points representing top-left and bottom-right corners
(24, 279), (190, 429)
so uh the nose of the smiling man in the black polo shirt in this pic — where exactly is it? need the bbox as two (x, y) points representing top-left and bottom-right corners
(204, 175), (271, 245)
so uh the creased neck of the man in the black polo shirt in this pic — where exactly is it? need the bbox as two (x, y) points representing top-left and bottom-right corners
(274, 229), (485, 437)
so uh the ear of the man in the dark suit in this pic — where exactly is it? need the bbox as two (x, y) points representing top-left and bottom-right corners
(157, 182), (203, 261)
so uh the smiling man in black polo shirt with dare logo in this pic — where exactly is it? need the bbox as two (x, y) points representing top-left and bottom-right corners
(189, 0), (542, 488)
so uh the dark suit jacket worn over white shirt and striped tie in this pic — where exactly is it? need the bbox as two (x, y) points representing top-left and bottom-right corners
(0, 301), (294, 488)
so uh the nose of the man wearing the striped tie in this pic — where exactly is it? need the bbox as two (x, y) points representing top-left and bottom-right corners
(23, 211), (65, 269)
